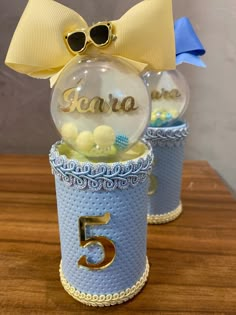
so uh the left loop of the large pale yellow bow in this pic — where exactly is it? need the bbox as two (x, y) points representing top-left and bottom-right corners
(6, 0), (87, 79)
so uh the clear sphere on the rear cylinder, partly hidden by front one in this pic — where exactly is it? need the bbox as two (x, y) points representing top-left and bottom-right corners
(143, 70), (190, 127)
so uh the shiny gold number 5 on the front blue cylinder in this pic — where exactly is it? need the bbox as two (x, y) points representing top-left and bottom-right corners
(78, 213), (116, 270)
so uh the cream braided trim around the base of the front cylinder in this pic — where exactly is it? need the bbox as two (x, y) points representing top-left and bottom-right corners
(60, 258), (149, 307)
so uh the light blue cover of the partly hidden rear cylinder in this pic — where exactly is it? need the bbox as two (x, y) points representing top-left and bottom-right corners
(144, 122), (188, 215)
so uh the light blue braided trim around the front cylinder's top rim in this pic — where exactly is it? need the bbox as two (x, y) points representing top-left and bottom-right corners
(49, 142), (153, 191)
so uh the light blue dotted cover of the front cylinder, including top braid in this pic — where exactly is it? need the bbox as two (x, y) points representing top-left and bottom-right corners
(50, 144), (153, 295)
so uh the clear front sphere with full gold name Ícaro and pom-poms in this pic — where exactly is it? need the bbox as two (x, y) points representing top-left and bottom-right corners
(51, 56), (151, 158)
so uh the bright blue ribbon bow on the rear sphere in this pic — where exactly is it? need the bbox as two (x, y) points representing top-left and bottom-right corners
(175, 17), (206, 68)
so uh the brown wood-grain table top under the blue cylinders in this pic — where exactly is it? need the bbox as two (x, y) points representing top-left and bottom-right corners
(0, 156), (236, 315)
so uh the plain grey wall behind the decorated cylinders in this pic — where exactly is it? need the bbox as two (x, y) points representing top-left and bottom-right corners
(0, 0), (236, 190)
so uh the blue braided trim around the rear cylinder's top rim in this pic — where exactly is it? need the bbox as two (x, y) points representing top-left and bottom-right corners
(144, 123), (189, 148)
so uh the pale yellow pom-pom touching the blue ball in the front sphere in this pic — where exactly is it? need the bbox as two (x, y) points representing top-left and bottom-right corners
(93, 125), (116, 149)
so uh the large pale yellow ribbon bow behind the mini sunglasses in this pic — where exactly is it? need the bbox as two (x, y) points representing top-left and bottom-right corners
(5, 0), (175, 79)
